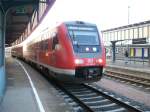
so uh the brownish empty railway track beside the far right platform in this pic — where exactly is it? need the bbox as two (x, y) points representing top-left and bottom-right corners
(105, 70), (150, 91)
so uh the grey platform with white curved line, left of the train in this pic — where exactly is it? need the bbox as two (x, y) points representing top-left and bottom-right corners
(0, 57), (72, 112)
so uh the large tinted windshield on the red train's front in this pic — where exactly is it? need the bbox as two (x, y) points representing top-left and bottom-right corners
(68, 27), (99, 45)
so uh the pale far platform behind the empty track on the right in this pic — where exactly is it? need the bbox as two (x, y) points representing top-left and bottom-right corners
(106, 59), (150, 74)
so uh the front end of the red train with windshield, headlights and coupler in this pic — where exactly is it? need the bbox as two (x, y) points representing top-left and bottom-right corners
(66, 22), (106, 83)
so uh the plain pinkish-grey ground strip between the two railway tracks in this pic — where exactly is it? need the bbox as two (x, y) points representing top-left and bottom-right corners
(97, 78), (150, 107)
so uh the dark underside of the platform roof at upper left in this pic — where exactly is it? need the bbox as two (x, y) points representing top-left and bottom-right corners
(0, 0), (55, 45)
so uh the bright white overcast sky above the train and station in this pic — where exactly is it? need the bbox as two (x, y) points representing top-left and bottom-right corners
(38, 0), (150, 30)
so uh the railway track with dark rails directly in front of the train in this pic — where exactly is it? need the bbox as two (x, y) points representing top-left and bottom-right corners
(54, 84), (143, 112)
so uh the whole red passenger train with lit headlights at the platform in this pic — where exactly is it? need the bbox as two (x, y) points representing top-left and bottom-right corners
(12, 21), (106, 83)
